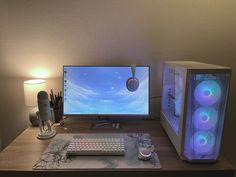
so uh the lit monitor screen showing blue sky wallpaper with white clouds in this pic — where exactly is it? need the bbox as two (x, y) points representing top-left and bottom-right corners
(63, 66), (149, 115)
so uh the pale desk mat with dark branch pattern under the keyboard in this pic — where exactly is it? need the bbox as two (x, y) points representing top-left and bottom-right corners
(33, 133), (161, 170)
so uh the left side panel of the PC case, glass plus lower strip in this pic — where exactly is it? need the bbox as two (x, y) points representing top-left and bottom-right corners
(161, 64), (187, 154)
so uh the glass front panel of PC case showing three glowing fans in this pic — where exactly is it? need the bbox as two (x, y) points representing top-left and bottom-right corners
(183, 70), (230, 161)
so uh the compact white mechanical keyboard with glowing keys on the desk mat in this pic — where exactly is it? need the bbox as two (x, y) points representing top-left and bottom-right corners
(67, 137), (125, 155)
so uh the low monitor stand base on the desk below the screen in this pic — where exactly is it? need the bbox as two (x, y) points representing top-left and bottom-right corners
(91, 120), (121, 130)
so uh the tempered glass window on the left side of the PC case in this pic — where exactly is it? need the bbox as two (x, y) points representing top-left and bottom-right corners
(162, 64), (184, 135)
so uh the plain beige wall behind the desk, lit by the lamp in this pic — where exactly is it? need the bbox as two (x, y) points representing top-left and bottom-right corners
(0, 0), (236, 169)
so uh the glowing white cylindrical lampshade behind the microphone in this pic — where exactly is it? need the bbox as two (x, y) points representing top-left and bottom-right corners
(24, 79), (46, 106)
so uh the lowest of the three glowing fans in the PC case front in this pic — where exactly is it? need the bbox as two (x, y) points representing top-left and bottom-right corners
(191, 131), (215, 155)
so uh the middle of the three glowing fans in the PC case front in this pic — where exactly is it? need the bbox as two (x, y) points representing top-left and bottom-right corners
(193, 107), (218, 130)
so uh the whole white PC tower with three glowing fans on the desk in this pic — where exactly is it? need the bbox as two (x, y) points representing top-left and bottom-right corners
(161, 61), (231, 162)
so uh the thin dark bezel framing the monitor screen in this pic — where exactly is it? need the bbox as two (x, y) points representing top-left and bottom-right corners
(62, 65), (151, 119)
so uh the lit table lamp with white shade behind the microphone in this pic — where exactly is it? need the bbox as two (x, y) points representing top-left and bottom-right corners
(24, 79), (46, 126)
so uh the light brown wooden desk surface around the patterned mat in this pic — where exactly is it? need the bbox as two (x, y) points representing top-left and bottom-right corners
(0, 120), (235, 177)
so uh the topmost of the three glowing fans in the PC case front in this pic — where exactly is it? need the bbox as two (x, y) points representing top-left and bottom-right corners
(194, 80), (221, 106)
